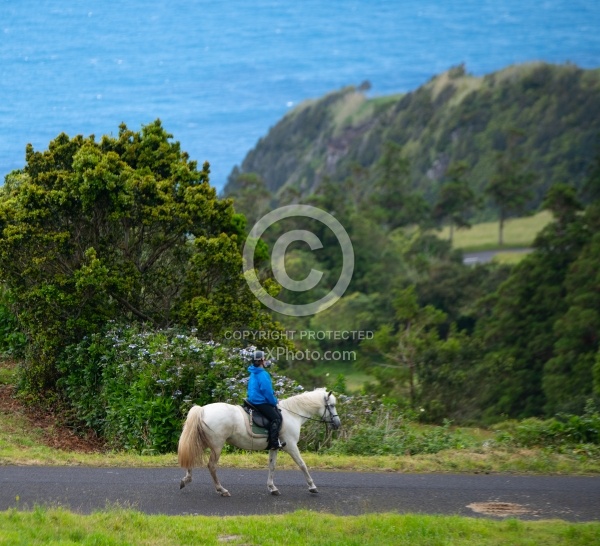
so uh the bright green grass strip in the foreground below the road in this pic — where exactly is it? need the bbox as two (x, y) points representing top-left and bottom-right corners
(0, 507), (600, 546)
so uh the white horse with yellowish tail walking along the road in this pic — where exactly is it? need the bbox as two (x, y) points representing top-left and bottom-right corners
(177, 389), (340, 497)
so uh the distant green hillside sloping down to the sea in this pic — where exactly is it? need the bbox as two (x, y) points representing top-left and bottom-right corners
(225, 63), (600, 211)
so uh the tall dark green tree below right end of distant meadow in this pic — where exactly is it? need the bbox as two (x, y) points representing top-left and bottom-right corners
(477, 189), (597, 418)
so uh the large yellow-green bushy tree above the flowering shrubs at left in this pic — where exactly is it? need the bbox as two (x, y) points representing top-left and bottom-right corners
(0, 120), (276, 391)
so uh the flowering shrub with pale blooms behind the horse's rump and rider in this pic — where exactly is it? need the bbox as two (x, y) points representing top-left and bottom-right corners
(59, 326), (302, 453)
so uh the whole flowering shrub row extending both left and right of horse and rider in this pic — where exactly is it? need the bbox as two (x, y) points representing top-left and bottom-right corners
(59, 318), (464, 455)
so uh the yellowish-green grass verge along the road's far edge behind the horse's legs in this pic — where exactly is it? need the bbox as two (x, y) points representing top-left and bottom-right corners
(0, 402), (600, 475)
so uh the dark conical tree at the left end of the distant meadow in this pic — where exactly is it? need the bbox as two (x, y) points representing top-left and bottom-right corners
(432, 161), (477, 242)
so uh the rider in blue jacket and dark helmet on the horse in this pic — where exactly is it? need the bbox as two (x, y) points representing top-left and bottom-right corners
(247, 351), (285, 449)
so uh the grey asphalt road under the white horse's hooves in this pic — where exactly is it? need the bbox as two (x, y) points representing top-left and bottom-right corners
(0, 466), (600, 521)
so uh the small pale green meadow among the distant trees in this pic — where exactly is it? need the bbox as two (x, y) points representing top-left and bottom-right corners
(438, 211), (552, 252)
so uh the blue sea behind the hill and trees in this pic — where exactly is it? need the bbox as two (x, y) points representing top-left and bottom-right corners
(0, 0), (600, 189)
